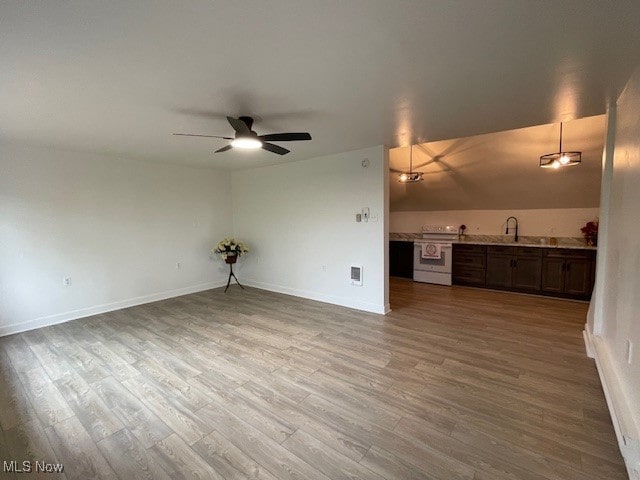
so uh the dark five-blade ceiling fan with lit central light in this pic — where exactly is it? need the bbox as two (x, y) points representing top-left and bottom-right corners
(174, 116), (311, 155)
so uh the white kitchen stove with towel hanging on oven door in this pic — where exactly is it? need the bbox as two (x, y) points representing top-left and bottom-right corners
(413, 225), (458, 285)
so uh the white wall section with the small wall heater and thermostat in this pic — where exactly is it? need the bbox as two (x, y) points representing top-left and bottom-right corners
(231, 146), (389, 313)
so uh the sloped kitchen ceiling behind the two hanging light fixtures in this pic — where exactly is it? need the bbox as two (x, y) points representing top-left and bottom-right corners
(389, 115), (606, 211)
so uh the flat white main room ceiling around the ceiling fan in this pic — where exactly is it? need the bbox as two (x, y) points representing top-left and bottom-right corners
(0, 0), (640, 168)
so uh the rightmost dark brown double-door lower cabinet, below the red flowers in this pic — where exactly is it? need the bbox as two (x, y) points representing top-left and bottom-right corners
(542, 249), (595, 300)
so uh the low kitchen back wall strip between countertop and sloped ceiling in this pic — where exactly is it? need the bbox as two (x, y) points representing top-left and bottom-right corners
(389, 208), (599, 237)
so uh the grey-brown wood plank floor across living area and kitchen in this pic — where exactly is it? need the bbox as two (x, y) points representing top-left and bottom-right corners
(0, 279), (626, 480)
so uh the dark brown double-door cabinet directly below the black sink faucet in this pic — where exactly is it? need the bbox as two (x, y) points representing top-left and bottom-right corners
(486, 245), (542, 292)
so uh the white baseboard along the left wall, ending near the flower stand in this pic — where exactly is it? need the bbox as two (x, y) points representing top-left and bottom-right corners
(0, 281), (226, 337)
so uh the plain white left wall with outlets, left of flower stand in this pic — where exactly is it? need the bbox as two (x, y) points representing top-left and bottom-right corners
(0, 145), (232, 335)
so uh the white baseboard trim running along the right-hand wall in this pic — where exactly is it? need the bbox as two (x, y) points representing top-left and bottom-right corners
(583, 328), (640, 479)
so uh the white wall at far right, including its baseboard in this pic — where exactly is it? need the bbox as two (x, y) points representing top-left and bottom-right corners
(586, 69), (640, 478)
